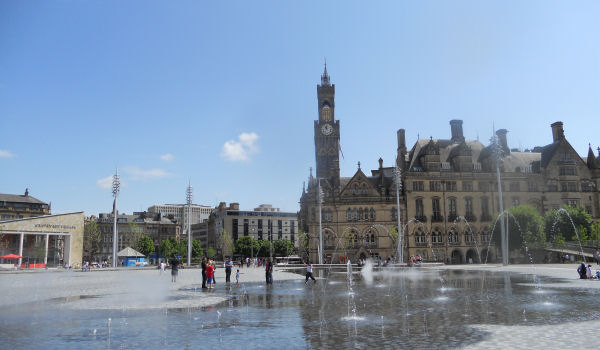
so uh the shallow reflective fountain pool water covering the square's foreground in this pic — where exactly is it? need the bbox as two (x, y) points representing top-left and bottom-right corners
(0, 269), (600, 349)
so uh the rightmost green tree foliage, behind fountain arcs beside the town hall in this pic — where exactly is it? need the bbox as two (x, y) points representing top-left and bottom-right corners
(544, 206), (593, 243)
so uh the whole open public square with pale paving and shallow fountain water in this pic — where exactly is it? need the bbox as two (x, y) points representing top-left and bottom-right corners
(0, 264), (600, 349)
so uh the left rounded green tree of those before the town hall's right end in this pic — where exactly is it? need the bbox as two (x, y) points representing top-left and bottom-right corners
(494, 205), (546, 250)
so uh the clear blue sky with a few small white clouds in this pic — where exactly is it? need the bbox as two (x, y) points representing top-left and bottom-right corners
(0, 1), (600, 215)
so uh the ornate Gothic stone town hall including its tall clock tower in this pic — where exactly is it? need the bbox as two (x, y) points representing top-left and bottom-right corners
(299, 67), (600, 263)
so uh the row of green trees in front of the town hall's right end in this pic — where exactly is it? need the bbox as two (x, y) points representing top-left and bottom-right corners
(493, 205), (600, 250)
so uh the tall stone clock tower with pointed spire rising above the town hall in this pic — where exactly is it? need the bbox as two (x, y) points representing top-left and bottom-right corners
(315, 63), (340, 189)
